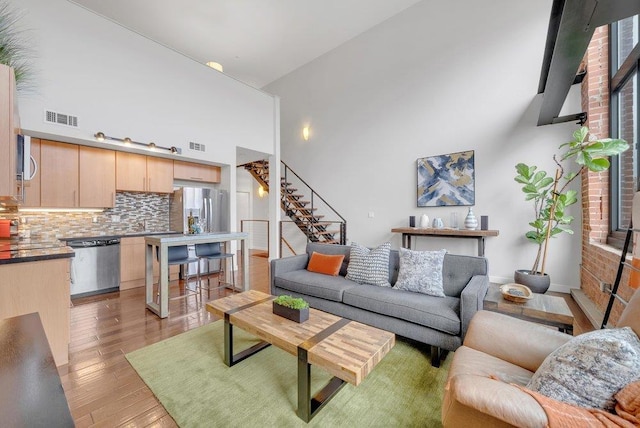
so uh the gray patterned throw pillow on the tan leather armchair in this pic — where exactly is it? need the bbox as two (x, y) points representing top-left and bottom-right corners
(527, 327), (640, 411)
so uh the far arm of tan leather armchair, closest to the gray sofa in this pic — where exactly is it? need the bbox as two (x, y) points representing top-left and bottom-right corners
(464, 311), (572, 372)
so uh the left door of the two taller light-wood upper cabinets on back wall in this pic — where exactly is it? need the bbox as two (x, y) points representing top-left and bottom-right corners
(40, 140), (79, 208)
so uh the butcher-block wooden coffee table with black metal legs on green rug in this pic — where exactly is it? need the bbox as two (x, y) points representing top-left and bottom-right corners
(206, 290), (395, 422)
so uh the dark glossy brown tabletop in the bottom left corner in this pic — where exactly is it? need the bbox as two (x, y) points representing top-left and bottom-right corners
(0, 313), (74, 427)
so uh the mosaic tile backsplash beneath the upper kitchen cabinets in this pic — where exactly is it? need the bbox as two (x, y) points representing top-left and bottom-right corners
(0, 192), (169, 241)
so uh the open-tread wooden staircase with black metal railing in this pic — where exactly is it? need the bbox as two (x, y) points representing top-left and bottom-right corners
(240, 160), (347, 245)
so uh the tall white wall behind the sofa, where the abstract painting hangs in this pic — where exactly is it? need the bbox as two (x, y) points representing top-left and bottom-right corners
(264, 0), (580, 290)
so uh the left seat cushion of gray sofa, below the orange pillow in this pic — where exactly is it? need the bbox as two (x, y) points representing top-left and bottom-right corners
(274, 270), (358, 302)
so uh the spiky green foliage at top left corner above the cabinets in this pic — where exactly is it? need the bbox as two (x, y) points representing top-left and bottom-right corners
(0, 0), (32, 90)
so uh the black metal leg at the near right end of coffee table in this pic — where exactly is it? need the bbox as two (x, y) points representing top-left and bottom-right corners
(298, 347), (345, 422)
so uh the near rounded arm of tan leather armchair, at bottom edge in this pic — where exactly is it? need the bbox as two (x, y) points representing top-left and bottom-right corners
(442, 374), (549, 428)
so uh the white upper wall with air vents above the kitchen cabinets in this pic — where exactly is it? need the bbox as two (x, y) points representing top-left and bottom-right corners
(9, 0), (274, 167)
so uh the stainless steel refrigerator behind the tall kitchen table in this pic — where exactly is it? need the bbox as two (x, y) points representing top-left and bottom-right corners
(169, 187), (229, 275)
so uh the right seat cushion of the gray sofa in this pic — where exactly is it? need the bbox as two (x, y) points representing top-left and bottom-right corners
(342, 285), (461, 335)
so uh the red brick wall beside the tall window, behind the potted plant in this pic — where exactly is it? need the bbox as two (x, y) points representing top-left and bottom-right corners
(580, 26), (633, 323)
